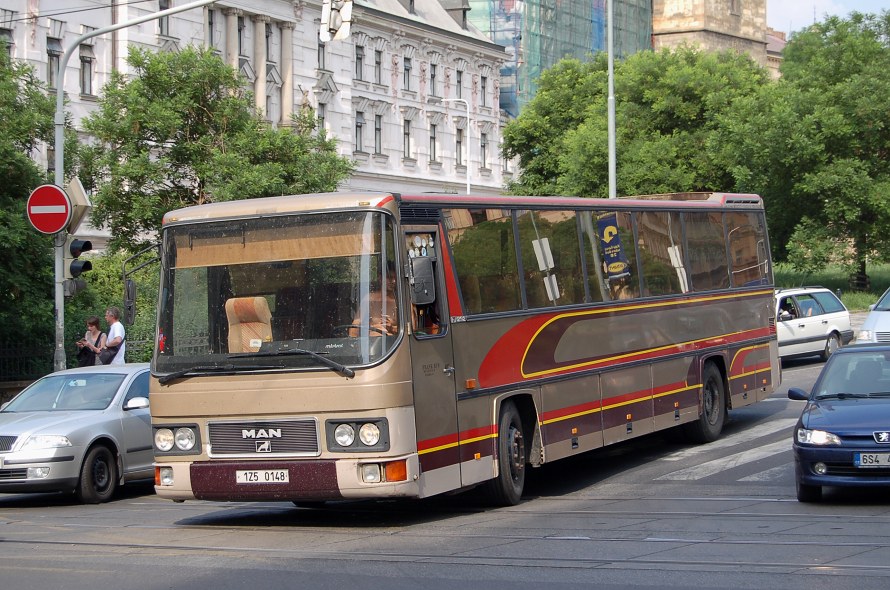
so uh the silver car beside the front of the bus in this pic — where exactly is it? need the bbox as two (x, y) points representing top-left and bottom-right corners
(0, 363), (154, 504)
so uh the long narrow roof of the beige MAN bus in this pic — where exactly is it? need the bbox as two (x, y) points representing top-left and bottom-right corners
(164, 192), (763, 225)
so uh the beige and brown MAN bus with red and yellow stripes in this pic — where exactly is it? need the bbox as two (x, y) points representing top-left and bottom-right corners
(151, 193), (780, 505)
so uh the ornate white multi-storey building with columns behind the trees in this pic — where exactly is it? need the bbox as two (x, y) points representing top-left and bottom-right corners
(0, 0), (510, 207)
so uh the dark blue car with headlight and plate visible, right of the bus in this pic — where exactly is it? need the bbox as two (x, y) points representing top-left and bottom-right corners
(788, 344), (890, 502)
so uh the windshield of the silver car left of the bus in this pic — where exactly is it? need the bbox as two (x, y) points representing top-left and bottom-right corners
(3, 373), (125, 412)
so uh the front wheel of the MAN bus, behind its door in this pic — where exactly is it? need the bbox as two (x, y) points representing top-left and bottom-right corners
(485, 401), (526, 506)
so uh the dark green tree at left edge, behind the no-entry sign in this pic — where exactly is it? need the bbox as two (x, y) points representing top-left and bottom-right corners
(0, 52), (55, 350)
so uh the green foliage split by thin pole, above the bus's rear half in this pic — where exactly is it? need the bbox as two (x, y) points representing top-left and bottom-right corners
(504, 47), (768, 197)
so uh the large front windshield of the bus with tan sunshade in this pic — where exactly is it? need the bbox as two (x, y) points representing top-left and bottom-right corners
(153, 211), (402, 375)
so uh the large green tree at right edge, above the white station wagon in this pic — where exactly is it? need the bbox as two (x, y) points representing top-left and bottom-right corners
(721, 12), (890, 288)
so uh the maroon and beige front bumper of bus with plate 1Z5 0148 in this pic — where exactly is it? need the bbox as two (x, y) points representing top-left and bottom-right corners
(155, 454), (420, 502)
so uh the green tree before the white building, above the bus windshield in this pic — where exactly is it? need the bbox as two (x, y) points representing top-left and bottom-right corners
(81, 47), (352, 251)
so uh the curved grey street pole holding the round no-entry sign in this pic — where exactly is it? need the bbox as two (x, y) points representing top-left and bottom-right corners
(53, 0), (216, 371)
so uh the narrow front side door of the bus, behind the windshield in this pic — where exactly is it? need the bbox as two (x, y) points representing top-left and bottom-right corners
(405, 231), (460, 496)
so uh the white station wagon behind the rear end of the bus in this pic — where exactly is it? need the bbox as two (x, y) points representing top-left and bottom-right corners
(776, 287), (853, 360)
